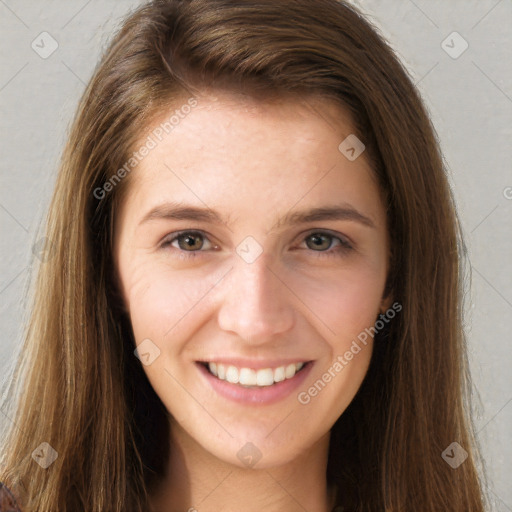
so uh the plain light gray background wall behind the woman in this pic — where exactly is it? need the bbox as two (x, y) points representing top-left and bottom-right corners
(0, 0), (512, 512)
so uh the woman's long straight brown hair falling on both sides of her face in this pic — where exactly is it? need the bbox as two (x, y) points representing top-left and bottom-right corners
(0, 0), (486, 512)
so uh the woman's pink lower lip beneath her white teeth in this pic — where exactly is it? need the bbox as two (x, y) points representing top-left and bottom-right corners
(196, 361), (313, 405)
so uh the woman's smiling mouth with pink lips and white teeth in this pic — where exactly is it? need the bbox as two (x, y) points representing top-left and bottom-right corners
(196, 361), (314, 404)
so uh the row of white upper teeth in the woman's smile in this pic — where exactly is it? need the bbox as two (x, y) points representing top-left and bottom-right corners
(208, 363), (304, 387)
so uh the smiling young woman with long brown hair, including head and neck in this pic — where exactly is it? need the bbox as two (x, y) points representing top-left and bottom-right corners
(0, 0), (485, 512)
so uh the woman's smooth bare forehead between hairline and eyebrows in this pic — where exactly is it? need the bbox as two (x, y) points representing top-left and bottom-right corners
(118, 92), (379, 228)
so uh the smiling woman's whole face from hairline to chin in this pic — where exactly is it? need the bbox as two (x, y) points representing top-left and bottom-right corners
(114, 93), (389, 468)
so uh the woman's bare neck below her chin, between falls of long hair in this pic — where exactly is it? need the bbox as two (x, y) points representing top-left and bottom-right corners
(151, 421), (335, 512)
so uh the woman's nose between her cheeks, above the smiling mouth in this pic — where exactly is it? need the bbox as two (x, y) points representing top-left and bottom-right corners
(218, 254), (294, 345)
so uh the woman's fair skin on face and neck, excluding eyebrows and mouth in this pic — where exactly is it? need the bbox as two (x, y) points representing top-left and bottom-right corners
(114, 91), (390, 512)
